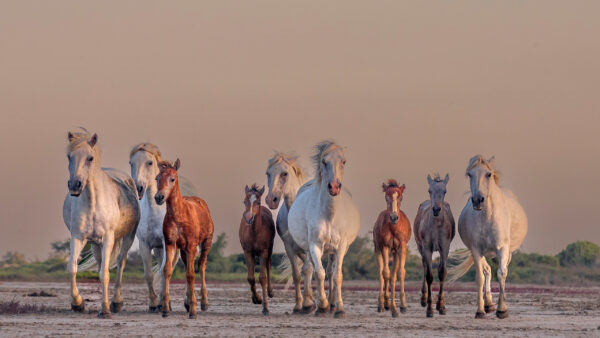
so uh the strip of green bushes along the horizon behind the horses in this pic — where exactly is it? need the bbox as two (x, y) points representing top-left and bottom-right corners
(0, 234), (600, 285)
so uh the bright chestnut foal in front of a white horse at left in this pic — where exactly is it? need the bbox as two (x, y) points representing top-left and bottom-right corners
(154, 159), (214, 319)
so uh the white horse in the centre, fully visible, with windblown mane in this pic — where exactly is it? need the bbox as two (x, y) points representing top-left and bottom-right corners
(288, 141), (360, 318)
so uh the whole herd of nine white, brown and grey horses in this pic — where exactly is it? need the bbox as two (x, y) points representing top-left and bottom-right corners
(63, 130), (527, 318)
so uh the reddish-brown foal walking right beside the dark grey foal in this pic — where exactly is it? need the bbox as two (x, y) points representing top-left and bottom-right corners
(373, 179), (410, 317)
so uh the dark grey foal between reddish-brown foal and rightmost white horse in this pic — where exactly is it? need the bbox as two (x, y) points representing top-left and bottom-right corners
(414, 174), (455, 317)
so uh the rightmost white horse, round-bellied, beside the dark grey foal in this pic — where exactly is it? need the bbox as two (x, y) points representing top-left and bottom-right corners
(449, 155), (527, 318)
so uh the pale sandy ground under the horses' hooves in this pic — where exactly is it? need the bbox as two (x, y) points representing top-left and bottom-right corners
(0, 282), (600, 337)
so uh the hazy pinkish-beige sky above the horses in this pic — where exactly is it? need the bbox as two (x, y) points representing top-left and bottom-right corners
(0, 0), (600, 258)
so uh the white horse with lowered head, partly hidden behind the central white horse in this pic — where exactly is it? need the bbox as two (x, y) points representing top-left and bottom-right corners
(266, 152), (316, 314)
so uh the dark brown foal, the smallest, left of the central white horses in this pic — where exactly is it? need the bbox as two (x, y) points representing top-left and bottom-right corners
(240, 184), (275, 316)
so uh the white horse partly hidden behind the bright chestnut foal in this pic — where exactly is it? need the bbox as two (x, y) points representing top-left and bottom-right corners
(129, 143), (179, 312)
